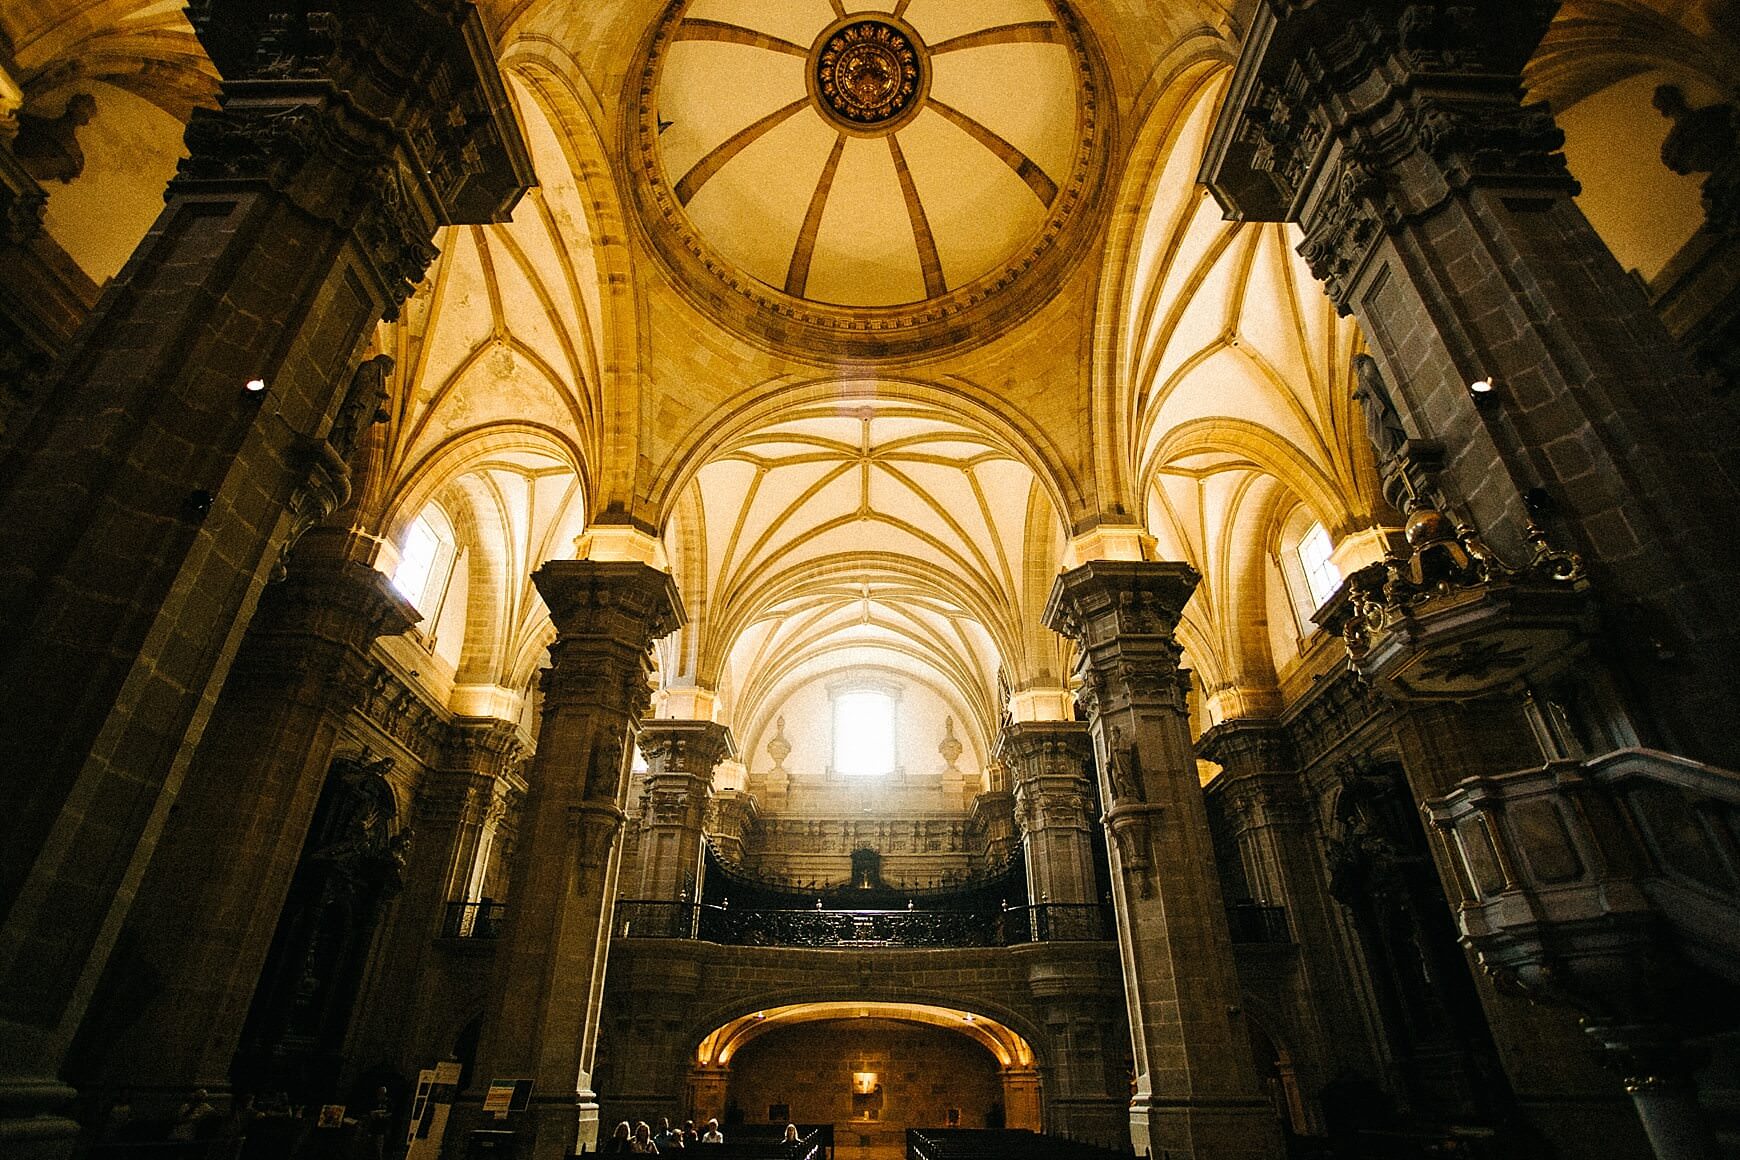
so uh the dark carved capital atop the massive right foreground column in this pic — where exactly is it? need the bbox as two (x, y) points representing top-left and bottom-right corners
(1201, 0), (1576, 313)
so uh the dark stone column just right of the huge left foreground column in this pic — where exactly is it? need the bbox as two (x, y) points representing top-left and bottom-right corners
(80, 539), (416, 1115)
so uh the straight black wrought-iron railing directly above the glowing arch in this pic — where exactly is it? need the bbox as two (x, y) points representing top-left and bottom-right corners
(616, 899), (1112, 948)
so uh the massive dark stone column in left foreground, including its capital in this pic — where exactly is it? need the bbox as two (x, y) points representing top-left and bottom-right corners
(0, 0), (532, 1157)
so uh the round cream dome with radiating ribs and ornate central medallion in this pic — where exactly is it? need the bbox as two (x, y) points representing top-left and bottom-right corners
(639, 0), (1096, 356)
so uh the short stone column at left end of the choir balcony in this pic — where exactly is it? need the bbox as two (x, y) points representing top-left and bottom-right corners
(633, 720), (738, 903)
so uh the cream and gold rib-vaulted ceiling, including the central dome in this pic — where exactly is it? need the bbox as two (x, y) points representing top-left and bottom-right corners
(0, 0), (1712, 786)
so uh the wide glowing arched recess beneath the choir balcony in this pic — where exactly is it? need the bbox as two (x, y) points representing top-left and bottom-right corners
(687, 1002), (1042, 1160)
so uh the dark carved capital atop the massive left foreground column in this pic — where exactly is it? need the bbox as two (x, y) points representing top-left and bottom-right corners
(171, 0), (536, 310)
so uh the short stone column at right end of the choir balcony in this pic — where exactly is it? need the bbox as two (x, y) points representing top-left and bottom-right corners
(997, 722), (1098, 918)
